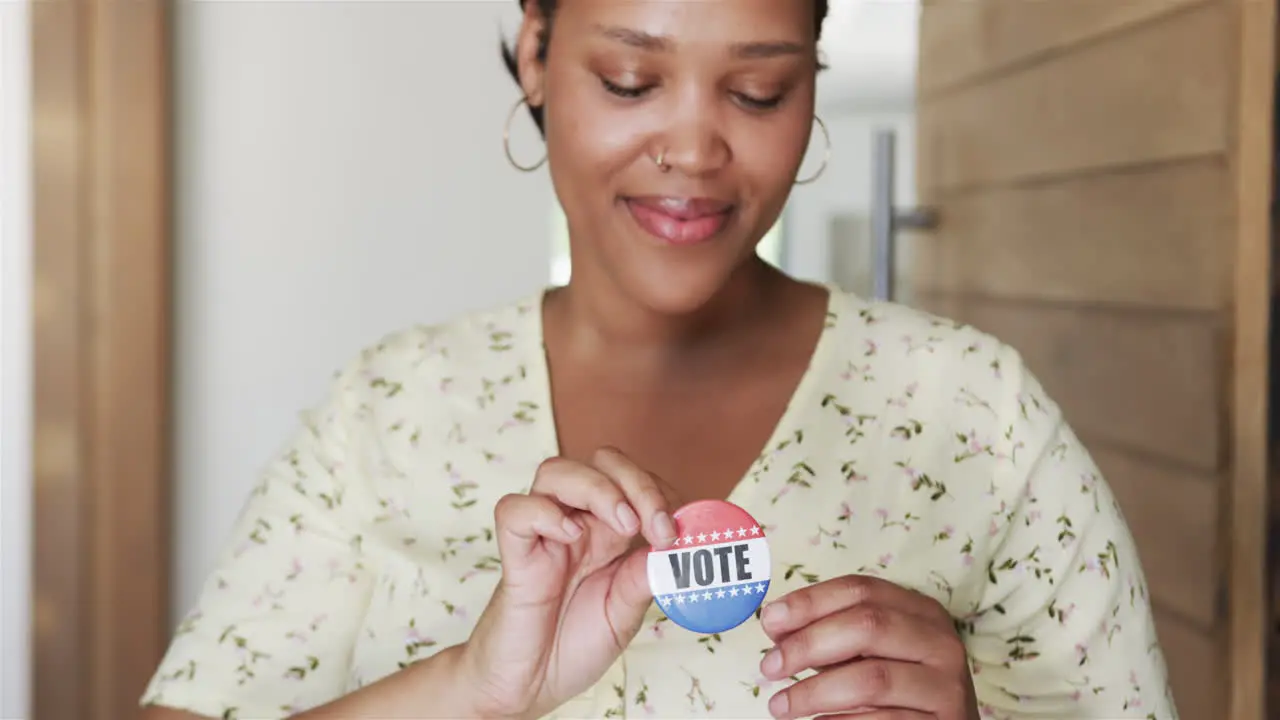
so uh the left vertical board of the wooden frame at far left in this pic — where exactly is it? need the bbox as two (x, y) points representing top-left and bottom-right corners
(31, 3), (91, 717)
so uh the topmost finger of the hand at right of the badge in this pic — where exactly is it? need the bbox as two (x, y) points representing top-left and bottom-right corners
(760, 575), (954, 642)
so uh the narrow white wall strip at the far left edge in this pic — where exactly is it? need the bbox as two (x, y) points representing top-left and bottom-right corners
(0, 3), (32, 717)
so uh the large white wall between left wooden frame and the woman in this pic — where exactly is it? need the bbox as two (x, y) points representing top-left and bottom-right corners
(174, 1), (552, 612)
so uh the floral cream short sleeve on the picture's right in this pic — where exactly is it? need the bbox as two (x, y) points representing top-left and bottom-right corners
(963, 350), (1178, 720)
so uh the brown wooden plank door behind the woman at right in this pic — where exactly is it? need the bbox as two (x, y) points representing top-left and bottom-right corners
(909, 0), (1275, 720)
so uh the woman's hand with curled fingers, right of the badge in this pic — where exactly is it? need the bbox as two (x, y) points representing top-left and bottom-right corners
(760, 575), (978, 720)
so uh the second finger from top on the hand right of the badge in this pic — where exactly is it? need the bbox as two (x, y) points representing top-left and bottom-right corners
(760, 605), (963, 680)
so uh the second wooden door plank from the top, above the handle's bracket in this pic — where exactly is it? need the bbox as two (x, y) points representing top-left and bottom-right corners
(916, 3), (1234, 190)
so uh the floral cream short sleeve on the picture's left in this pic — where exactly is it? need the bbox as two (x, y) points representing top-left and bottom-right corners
(142, 363), (372, 719)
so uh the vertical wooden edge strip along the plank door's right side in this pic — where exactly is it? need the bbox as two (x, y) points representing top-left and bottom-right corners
(1225, 0), (1276, 720)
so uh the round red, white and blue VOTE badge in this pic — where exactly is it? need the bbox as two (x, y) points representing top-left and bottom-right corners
(649, 500), (771, 634)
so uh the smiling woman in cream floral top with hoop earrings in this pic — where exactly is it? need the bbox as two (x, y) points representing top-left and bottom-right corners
(143, 0), (1176, 720)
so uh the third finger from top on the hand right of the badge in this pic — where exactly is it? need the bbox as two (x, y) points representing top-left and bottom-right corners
(769, 660), (966, 719)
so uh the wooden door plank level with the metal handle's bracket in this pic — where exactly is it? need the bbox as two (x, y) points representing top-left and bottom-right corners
(913, 158), (1234, 310)
